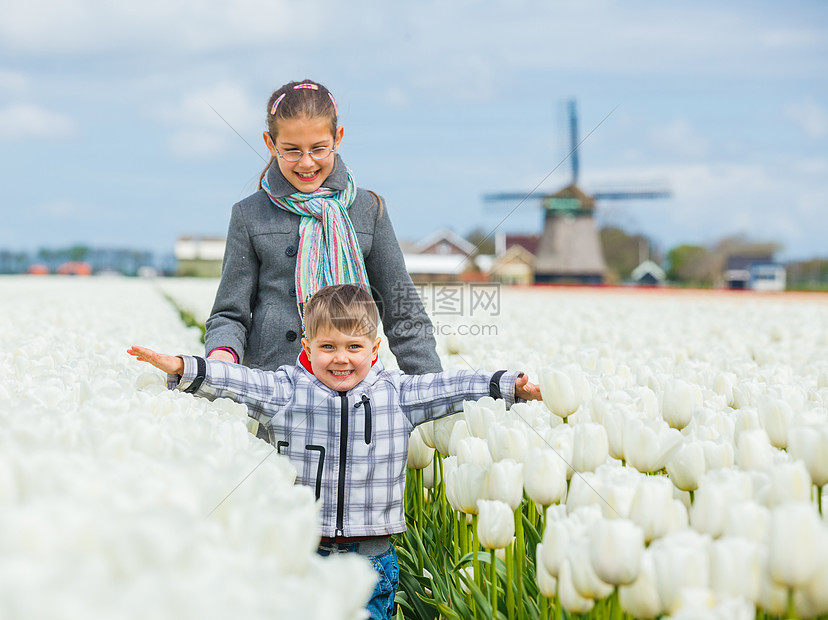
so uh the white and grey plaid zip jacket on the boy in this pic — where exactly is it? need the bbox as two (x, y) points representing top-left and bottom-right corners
(173, 356), (518, 537)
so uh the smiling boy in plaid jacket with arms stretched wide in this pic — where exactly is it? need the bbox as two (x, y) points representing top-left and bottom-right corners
(127, 284), (540, 618)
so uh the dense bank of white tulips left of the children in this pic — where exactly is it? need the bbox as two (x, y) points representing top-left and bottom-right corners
(0, 277), (374, 620)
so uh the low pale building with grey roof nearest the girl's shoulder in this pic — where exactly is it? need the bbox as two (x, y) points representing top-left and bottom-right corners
(401, 229), (479, 284)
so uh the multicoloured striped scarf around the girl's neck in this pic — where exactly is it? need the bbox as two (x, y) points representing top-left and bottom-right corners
(262, 168), (371, 316)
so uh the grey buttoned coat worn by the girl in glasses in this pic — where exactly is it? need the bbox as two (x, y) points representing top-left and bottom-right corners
(205, 155), (442, 374)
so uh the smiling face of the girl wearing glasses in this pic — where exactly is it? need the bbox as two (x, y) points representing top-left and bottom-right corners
(264, 117), (345, 194)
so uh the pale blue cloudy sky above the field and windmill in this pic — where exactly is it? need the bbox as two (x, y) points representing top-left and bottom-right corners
(0, 0), (828, 260)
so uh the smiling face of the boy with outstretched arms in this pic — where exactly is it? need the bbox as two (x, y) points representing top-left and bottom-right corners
(302, 326), (380, 392)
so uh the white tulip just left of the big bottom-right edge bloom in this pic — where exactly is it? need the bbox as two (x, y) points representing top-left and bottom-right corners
(710, 537), (762, 603)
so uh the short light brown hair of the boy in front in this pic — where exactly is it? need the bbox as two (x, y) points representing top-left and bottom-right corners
(304, 284), (379, 340)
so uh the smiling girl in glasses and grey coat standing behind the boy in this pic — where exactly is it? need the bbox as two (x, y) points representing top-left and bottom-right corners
(206, 80), (442, 374)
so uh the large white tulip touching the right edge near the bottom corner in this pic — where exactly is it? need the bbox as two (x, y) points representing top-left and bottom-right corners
(768, 502), (825, 588)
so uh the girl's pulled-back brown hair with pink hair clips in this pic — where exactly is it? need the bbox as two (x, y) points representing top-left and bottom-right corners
(259, 80), (337, 189)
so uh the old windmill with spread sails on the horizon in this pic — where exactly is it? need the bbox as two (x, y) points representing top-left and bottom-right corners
(484, 100), (670, 284)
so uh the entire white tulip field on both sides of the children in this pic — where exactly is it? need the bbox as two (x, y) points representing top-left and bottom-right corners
(0, 277), (828, 620)
